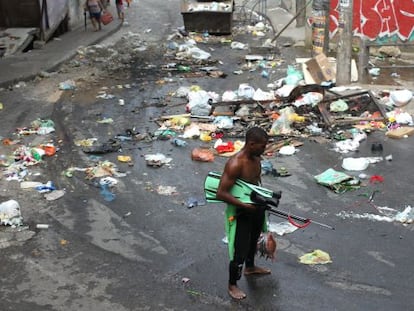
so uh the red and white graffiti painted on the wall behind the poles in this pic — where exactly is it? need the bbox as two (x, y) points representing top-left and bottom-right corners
(329, 0), (414, 40)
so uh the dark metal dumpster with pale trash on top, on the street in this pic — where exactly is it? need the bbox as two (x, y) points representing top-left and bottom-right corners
(181, 0), (233, 35)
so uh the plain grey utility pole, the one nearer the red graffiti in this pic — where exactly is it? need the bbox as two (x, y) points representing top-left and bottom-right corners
(336, 0), (354, 85)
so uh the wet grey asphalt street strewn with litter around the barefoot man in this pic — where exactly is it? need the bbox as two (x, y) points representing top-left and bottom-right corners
(0, 0), (414, 311)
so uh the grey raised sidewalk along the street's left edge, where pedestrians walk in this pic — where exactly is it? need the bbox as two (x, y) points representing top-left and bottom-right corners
(0, 7), (121, 87)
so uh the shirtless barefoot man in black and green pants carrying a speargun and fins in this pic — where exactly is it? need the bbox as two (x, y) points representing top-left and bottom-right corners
(217, 127), (270, 299)
